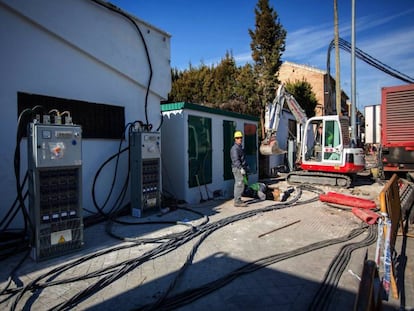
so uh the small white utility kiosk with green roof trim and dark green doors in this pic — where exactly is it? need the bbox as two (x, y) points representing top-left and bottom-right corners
(161, 102), (259, 204)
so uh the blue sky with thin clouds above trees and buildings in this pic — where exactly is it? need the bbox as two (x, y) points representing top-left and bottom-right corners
(110, 0), (414, 110)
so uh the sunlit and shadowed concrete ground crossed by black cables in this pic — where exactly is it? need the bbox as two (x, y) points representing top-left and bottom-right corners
(0, 178), (414, 311)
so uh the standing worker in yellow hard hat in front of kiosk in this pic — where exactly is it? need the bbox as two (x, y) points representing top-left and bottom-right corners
(230, 131), (249, 207)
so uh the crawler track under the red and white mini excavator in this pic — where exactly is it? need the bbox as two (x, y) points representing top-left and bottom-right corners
(286, 171), (352, 188)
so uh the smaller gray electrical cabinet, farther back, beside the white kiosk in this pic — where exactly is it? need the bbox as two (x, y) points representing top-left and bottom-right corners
(129, 131), (162, 217)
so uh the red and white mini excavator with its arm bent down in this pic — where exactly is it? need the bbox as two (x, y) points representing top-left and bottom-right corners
(259, 84), (365, 188)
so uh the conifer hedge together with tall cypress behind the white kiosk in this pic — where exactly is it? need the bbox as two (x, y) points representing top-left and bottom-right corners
(168, 0), (286, 125)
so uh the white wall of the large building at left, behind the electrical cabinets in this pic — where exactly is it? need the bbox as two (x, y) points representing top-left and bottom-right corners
(0, 0), (171, 224)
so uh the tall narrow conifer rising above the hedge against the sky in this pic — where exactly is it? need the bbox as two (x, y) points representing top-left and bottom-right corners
(249, 0), (286, 135)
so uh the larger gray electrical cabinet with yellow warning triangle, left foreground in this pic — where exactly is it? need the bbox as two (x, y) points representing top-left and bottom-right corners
(28, 123), (84, 261)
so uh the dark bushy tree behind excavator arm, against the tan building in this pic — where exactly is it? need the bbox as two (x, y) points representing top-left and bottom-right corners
(285, 80), (318, 118)
